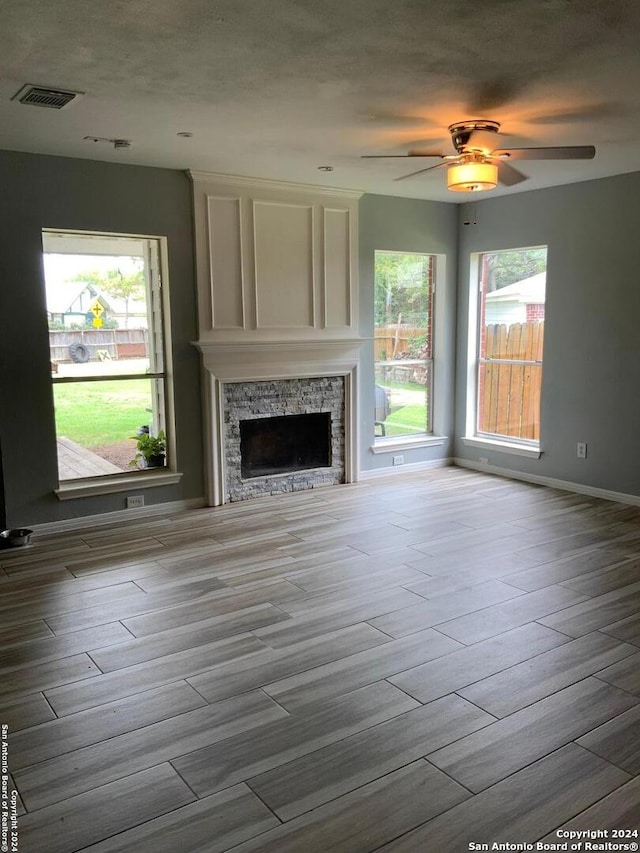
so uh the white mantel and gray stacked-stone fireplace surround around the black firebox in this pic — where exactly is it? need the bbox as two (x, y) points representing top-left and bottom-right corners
(196, 338), (362, 506)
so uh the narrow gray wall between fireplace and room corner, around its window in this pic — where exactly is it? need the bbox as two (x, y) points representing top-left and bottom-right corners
(359, 195), (458, 471)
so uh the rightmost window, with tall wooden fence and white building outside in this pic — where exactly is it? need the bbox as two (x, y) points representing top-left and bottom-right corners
(475, 247), (547, 445)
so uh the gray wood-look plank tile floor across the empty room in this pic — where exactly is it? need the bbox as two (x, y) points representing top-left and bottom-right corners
(0, 468), (640, 853)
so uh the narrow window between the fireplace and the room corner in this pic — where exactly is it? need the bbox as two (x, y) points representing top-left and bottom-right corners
(374, 251), (435, 440)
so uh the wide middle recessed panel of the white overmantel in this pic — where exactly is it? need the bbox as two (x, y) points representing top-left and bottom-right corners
(253, 201), (315, 329)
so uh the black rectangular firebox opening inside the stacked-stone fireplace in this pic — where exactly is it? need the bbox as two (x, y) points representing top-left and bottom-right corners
(240, 412), (331, 479)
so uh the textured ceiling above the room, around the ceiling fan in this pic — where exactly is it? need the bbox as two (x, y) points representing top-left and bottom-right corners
(0, 0), (640, 202)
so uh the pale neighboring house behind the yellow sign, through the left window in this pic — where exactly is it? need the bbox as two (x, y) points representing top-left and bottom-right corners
(46, 276), (148, 329)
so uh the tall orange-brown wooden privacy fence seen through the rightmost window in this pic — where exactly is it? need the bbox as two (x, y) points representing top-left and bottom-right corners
(478, 323), (544, 441)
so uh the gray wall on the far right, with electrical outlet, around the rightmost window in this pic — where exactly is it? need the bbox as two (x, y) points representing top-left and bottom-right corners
(455, 173), (640, 495)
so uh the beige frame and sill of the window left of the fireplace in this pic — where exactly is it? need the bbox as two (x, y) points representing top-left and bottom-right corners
(42, 228), (182, 500)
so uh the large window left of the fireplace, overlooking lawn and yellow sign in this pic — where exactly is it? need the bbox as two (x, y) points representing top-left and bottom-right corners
(43, 231), (171, 485)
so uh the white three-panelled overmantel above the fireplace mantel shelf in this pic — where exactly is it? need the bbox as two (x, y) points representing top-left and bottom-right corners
(190, 172), (360, 343)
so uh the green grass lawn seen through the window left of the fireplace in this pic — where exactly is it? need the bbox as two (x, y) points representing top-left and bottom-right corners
(54, 379), (151, 447)
